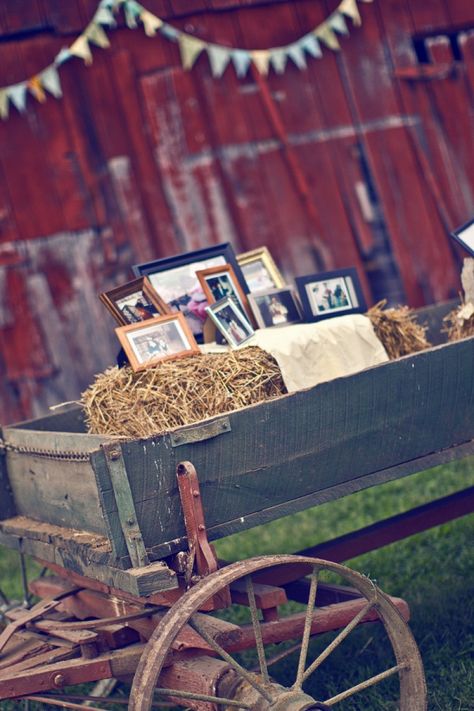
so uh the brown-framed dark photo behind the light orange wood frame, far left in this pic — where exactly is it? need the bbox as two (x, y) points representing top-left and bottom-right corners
(99, 277), (171, 326)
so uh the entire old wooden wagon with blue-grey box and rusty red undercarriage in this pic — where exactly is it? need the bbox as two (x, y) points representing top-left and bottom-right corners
(0, 308), (474, 711)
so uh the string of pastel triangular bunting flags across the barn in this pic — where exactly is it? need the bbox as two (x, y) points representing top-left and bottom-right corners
(0, 0), (373, 120)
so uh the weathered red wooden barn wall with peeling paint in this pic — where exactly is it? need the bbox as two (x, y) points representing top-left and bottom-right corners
(0, 0), (474, 422)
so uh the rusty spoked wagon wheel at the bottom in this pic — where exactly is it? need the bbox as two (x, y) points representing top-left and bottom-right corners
(129, 555), (426, 711)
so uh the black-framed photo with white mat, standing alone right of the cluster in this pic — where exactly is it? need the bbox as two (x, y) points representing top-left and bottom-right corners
(296, 267), (367, 321)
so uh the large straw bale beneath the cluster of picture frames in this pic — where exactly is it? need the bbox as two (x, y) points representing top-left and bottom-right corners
(81, 347), (286, 438)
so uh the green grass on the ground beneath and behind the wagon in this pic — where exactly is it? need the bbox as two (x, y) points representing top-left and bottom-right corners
(0, 458), (474, 711)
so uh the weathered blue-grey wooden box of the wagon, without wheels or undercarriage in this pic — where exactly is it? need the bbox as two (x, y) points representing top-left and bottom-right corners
(0, 300), (474, 595)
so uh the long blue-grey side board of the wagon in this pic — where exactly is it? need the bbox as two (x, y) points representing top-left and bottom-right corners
(117, 339), (474, 547)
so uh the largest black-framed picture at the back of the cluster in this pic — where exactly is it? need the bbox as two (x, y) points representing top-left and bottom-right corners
(132, 243), (248, 343)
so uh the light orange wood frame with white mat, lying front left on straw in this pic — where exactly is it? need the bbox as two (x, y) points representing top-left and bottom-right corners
(115, 313), (200, 372)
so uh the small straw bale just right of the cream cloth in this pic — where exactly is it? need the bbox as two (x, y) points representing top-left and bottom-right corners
(367, 300), (431, 360)
